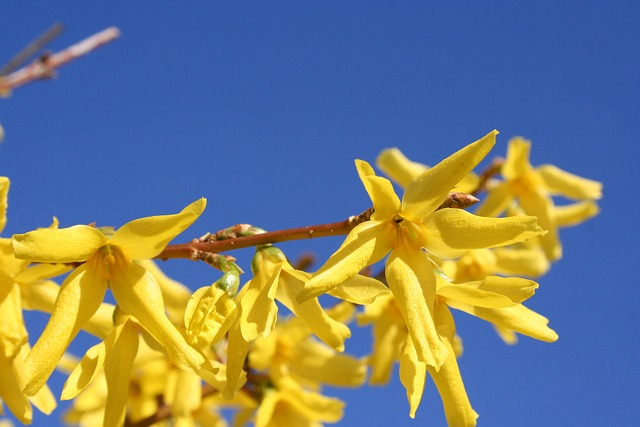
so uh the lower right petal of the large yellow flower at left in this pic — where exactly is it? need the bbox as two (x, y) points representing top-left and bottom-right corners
(110, 260), (205, 372)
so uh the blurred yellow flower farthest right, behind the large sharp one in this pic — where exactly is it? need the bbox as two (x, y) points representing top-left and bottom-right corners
(476, 137), (602, 261)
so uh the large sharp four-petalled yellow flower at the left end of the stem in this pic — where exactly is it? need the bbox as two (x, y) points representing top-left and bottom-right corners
(13, 199), (212, 395)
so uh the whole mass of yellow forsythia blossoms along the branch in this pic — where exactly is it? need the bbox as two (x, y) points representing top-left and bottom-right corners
(0, 131), (601, 427)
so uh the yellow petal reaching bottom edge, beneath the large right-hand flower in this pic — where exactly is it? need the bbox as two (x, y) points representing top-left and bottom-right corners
(427, 339), (478, 427)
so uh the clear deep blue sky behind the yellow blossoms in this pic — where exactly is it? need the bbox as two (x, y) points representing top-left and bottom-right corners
(0, 1), (640, 427)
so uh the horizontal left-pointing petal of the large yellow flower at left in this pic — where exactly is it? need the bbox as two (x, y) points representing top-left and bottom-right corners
(13, 225), (107, 264)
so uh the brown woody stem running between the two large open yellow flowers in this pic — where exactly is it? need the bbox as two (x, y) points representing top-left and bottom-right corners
(156, 209), (373, 260)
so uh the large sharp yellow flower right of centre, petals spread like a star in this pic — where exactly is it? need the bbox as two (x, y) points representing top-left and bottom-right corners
(297, 131), (543, 369)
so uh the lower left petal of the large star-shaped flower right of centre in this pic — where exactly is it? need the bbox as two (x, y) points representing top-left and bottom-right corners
(297, 221), (395, 302)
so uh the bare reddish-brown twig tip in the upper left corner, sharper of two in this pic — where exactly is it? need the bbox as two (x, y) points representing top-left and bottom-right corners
(0, 27), (120, 93)
